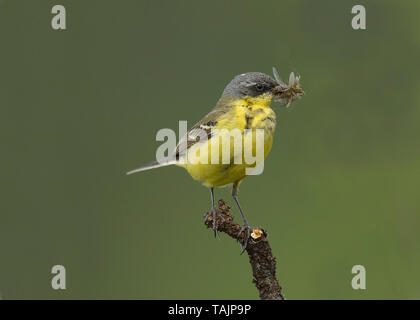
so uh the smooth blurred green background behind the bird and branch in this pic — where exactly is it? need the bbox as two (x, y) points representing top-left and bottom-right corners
(0, 0), (420, 299)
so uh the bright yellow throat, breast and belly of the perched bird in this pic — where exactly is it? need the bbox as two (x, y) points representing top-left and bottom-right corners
(179, 99), (275, 187)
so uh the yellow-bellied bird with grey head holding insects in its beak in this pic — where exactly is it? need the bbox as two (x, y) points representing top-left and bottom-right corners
(127, 67), (304, 253)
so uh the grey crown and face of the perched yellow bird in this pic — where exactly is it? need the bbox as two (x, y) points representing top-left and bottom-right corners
(222, 72), (279, 98)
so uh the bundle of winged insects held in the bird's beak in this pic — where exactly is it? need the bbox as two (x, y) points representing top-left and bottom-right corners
(273, 67), (305, 108)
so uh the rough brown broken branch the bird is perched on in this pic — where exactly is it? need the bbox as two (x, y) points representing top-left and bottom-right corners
(204, 200), (284, 300)
